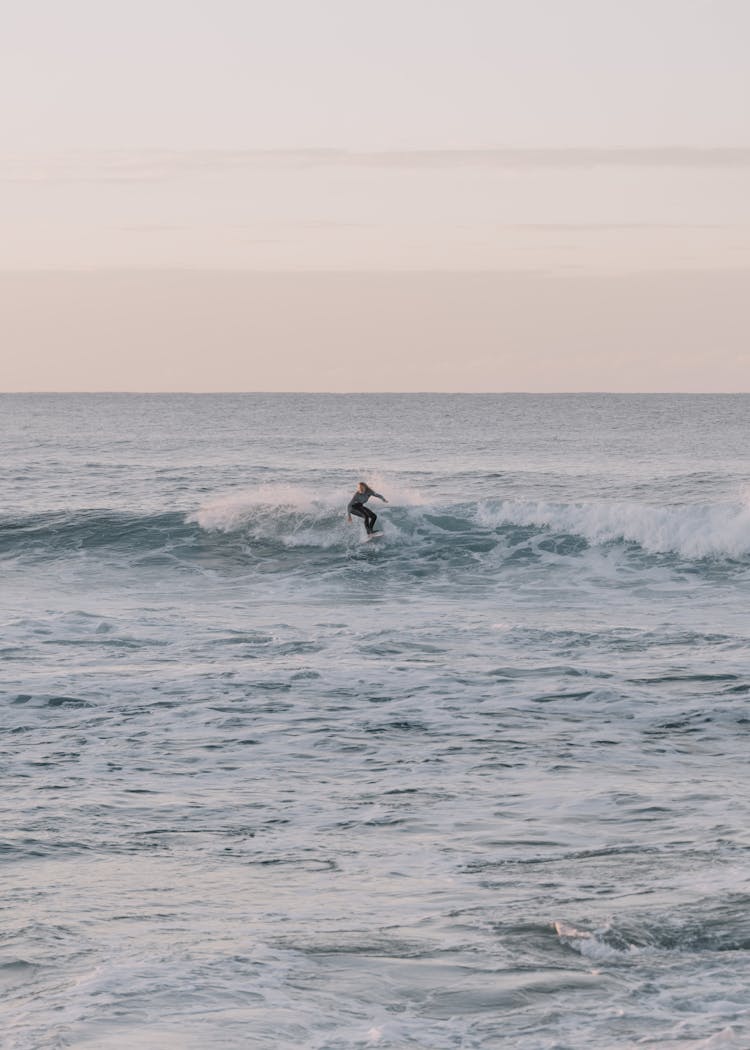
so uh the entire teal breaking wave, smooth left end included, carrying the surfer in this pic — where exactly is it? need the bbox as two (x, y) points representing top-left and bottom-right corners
(0, 490), (750, 568)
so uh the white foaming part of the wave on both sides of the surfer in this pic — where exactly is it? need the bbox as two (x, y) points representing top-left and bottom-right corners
(188, 486), (750, 561)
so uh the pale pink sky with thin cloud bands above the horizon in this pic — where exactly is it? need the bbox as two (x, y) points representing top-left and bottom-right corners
(0, 0), (750, 391)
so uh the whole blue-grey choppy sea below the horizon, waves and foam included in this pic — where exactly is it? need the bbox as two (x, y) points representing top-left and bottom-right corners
(0, 395), (750, 1050)
